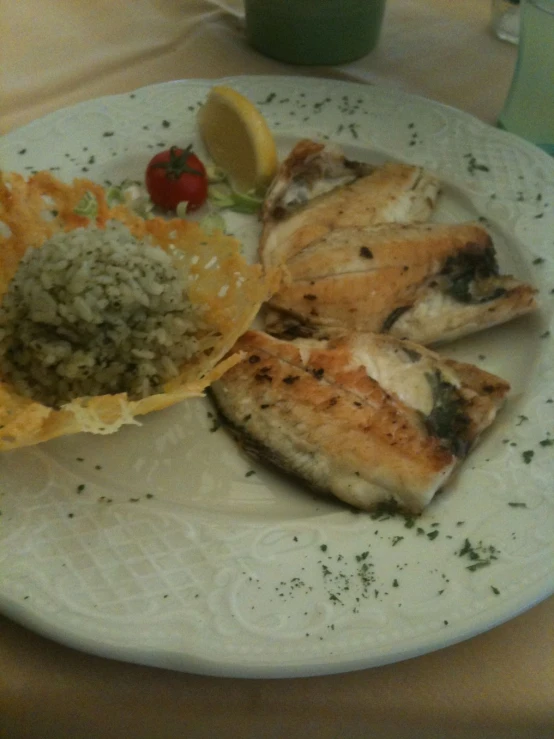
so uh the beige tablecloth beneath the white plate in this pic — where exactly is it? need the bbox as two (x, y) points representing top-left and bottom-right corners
(0, 0), (554, 739)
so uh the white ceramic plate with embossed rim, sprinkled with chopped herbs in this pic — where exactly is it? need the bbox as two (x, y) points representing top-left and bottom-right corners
(0, 77), (554, 676)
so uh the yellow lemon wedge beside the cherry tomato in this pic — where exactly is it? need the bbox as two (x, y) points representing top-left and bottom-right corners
(198, 85), (277, 193)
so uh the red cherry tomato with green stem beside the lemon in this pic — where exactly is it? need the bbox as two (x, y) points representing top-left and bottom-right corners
(145, 146), (208, 210)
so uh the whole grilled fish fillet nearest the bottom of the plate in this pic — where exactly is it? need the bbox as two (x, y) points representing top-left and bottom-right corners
(211, 331), (509, 513)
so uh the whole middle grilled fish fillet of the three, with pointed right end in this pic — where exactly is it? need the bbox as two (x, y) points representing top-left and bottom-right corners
(265, 223), (536, 344)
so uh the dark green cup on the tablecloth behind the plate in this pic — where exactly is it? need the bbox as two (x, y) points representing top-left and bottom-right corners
(244, 0), (385, 64)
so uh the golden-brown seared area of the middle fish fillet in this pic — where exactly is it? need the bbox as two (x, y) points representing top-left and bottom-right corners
(269, 224), (490, 331)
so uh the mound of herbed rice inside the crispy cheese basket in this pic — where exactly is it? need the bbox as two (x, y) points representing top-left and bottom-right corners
(0, 221), (202, 408)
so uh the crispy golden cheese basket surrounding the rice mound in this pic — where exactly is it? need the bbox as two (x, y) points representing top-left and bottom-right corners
(0, 172), (276, 450)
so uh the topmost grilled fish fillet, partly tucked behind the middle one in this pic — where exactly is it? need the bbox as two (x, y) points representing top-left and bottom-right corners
(259, 140), (439, 267)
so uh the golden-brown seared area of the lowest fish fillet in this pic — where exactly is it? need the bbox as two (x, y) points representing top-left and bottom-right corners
(212, 332), (448, 511)
